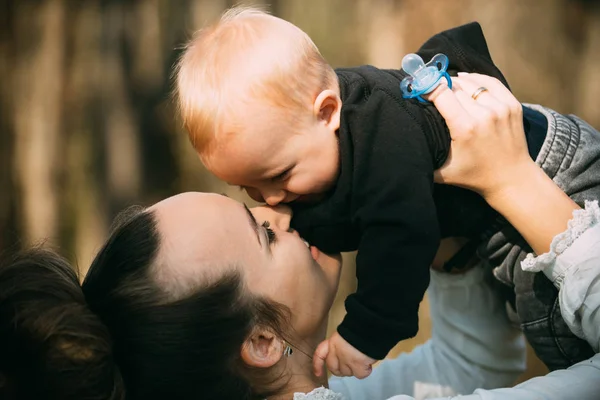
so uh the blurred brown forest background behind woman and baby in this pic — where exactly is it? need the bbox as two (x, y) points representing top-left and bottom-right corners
(0, 0), (600, 386)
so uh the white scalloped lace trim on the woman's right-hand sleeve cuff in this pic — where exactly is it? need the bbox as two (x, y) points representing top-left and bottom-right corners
(521, 200), (600, 272)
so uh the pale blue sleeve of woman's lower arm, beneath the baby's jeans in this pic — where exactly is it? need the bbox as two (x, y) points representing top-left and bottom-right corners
(330, 268), (525, 400)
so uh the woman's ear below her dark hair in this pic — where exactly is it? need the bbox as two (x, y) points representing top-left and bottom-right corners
(241, 329), (284, 368)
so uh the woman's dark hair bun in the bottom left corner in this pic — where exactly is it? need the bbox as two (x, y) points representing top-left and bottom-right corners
(0, 248), (124, 400)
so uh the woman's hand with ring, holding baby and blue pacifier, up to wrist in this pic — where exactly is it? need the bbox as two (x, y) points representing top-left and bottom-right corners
(429, 74), (538, 198)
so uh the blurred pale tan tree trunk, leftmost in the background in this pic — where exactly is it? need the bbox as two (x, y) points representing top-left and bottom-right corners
(11, 0), (66, 245)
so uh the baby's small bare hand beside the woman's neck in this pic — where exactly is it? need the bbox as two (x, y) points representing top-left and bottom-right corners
(313, 332), (377, 379)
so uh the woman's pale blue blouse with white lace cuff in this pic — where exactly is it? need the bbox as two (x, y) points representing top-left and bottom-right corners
(294, 201), (600, 400)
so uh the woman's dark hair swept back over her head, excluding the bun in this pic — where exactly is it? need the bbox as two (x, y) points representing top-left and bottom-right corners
(83, 209), (288, 400)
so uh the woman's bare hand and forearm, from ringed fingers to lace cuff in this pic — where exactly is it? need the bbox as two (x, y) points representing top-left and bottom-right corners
(431, 74), (579, 254)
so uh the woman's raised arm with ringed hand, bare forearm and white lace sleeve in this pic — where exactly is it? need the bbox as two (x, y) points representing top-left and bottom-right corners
(432, 74), (600, 351)
